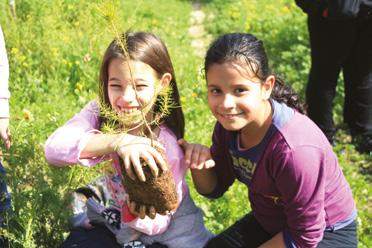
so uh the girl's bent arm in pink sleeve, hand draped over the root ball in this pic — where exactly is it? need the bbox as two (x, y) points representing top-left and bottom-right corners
(44, 101), (167, 181)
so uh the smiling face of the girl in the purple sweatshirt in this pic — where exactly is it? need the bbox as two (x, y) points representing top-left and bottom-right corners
(207, 62), (275, 131)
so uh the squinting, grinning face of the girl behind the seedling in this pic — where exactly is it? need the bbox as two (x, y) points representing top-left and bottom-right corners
(107, 58), (159, 119)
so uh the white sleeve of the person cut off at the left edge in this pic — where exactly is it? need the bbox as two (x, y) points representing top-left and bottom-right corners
(0, 27), (10, 118)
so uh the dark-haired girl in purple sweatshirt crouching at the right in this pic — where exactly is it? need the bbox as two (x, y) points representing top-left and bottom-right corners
(179, 33), (357, 248)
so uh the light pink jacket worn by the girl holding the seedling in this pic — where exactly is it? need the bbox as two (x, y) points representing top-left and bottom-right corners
(44, 101), (188, 235)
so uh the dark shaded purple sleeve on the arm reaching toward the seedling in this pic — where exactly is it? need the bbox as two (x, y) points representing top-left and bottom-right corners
(203, 122), (235, 199)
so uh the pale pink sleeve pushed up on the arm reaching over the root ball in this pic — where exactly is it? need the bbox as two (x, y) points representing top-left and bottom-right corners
(44, 101), (107, 166)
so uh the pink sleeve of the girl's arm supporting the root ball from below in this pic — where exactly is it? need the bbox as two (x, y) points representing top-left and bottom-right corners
(126, 126), (188, 235)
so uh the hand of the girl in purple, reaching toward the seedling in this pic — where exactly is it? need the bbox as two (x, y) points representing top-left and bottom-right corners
(177, 139), (215, 170)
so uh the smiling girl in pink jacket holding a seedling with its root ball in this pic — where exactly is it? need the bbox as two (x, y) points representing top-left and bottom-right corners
(45, 32), (212, 248)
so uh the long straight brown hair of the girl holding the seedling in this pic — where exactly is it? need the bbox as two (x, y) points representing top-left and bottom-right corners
(99, 31), (185, 139)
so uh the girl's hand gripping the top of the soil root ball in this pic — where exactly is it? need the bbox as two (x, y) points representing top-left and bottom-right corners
(115, 137), (168, 182)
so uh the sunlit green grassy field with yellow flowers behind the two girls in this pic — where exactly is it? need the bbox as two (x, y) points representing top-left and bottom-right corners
(0, 0), (372, 248)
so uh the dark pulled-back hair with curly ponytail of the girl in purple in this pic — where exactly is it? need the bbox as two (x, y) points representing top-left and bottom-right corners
(204, 33), (305, 113)
